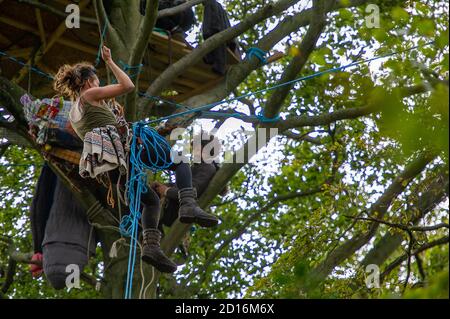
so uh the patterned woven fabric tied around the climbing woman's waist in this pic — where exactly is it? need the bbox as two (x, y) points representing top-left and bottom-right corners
(79, 125), (127, 178)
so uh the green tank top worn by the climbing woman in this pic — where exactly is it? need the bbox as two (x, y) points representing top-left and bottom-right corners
(71, 102), (117, 140)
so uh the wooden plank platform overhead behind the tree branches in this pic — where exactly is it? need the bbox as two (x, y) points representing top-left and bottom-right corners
(0, 0), (282, 102)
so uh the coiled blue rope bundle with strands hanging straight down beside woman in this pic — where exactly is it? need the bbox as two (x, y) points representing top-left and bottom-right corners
(119, 122), (173, 299)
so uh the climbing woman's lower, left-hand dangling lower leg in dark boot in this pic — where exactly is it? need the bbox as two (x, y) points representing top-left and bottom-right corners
(141, 188), (177, 273)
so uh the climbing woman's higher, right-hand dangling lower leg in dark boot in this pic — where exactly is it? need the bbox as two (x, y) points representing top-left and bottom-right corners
(172, 163), (219, 227)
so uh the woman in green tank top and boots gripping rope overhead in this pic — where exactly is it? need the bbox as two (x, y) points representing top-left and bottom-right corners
(54, 46), (218, 273)
